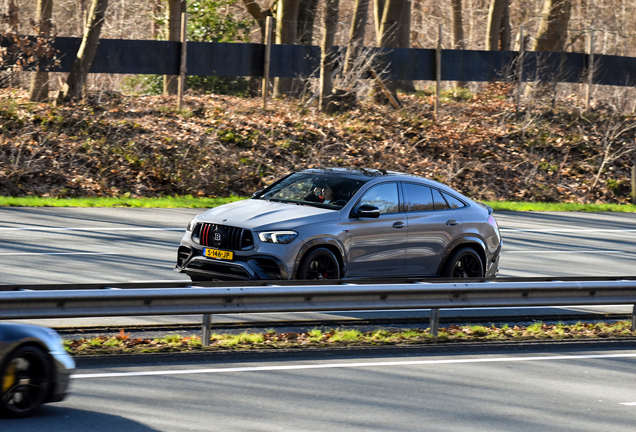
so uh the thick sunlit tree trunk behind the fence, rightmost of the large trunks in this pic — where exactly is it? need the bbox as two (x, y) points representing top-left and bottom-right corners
(532, 0), (572, 52)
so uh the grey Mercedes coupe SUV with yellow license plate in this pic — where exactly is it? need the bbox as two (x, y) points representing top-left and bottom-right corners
(175, 168), (503, 281)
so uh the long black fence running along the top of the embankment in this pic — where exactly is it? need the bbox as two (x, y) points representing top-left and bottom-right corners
(6, 37), (636, 86)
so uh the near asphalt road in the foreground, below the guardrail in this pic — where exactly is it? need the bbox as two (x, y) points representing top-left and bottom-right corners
(0, 344), (636, 432)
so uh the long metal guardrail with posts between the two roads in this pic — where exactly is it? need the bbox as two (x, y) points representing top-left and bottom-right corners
(0, 277), (636, 344)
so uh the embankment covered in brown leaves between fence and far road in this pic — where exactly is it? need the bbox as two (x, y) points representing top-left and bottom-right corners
(0, 85), (636, 203)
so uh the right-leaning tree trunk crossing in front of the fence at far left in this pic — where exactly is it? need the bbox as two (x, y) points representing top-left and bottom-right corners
(57, 0), (108, 103)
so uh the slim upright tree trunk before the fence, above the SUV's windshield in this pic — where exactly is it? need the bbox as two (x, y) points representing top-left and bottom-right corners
(320, 0), (339, 112)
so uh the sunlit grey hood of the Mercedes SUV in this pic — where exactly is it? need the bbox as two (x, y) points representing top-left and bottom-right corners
(198, 199), (340, 230)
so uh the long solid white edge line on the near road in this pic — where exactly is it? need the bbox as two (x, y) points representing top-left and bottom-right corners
(71, 353), (636, 379)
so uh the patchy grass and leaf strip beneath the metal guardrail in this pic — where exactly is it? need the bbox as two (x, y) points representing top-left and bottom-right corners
(64, 321), (636, 356)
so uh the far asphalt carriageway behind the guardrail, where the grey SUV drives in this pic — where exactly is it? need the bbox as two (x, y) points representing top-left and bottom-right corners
(0, 208), (636, 327)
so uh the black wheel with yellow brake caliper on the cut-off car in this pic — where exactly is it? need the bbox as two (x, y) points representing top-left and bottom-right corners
(0, 346), (53, 418)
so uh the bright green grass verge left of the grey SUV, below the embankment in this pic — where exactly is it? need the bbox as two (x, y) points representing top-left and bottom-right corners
(0, 195), (245, 208)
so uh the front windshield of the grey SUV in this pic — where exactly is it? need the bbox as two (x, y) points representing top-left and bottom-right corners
(255, 172), (367, 210)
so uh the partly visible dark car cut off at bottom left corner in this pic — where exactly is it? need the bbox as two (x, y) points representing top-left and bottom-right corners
(0, 323), (75, 417)
